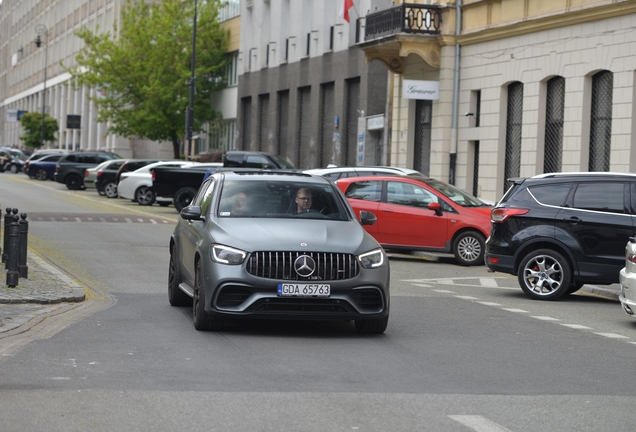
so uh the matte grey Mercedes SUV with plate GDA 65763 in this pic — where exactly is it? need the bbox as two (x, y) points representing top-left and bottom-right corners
(168, 171), (390, 333)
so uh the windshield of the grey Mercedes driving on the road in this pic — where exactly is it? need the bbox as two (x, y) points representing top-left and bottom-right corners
(218, 181), (349, 221)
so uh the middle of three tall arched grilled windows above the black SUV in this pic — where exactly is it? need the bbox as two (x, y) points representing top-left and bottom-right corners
(543, 76), (565, 173)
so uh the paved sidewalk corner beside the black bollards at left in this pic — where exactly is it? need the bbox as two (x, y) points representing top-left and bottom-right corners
(0, 250), (86, 334)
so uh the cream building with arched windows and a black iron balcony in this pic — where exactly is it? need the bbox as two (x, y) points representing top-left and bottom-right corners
(359, 0), (636, 200)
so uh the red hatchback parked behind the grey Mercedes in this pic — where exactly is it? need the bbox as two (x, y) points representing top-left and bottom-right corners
(336, 176), (492, 265)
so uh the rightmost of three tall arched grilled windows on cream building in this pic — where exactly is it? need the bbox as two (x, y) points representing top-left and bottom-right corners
(589, 71), (614, 171)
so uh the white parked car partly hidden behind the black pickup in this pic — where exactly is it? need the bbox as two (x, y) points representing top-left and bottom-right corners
(117, 160), (196, 206)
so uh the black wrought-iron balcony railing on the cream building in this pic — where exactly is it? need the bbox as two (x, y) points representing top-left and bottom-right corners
(364, 3), (442, 41)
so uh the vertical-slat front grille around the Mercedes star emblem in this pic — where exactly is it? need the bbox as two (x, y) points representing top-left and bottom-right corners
(247, 252), (360, 281)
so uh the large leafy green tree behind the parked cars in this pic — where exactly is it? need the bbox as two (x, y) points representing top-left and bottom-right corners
(67, 0), (229, 158)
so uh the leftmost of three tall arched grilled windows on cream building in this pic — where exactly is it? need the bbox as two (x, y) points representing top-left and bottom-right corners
(504, 82), (523, 190)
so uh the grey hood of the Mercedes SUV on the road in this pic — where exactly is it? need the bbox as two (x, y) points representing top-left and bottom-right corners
(211, 218), (379, 254)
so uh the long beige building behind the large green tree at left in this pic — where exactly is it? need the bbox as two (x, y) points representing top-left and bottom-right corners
(0, 0), (240, 158)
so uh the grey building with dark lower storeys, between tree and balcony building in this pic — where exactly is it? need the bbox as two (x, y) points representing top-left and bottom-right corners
(236, 0), (389, 168)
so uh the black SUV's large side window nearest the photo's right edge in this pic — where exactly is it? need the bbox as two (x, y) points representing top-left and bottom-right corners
(572, 183), (625, 213)
